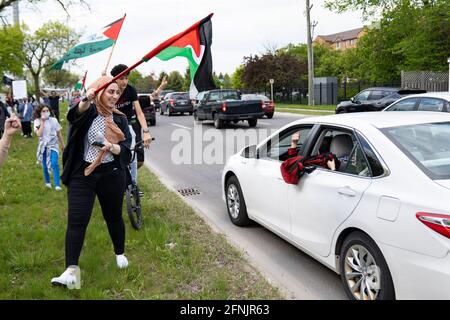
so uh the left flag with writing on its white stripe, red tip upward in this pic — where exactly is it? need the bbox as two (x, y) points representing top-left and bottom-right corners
(51, 15), (126, 70)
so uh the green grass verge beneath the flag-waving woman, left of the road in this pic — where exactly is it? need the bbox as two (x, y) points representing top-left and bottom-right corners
(0, 103), (283, 299)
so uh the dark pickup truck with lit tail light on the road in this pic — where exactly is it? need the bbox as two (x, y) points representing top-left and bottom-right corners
(194, 89), (264, 129)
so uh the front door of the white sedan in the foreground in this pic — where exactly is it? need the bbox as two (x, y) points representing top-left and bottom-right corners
(244, 125), (312, 236)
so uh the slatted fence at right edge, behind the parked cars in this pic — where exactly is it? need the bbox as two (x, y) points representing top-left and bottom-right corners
(402, 71), (449, 91)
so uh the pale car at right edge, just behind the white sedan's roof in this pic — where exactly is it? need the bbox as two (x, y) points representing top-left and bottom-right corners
(382, 92), (450, 112)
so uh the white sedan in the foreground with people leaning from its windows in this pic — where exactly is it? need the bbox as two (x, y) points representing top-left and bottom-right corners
(222, 112), (450, 300)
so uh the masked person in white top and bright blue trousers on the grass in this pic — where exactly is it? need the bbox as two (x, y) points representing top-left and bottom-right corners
(33, 104), (64, 191)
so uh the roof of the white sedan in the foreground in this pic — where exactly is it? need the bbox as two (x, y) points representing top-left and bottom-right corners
(291, 111), (450, 130)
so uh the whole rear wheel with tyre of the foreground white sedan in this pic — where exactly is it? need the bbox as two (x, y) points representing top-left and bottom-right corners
(339, 232), (395, 300)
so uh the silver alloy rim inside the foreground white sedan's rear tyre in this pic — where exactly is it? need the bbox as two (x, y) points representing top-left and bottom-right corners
(344, 245), (381, 300)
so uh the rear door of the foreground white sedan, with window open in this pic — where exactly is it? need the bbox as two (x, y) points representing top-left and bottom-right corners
(287, 127), (371, 257)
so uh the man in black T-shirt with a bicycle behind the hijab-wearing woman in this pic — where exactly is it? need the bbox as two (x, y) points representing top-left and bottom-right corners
(111, 64), (156, 183)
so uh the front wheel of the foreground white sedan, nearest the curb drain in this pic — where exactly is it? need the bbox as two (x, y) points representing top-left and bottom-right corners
(225, 176), (251, 227)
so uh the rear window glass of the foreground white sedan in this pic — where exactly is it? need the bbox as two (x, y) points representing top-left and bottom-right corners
(382, 122), (450, 179)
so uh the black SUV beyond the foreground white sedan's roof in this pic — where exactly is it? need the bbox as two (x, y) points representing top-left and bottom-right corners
(336, 87), (426, 113)
